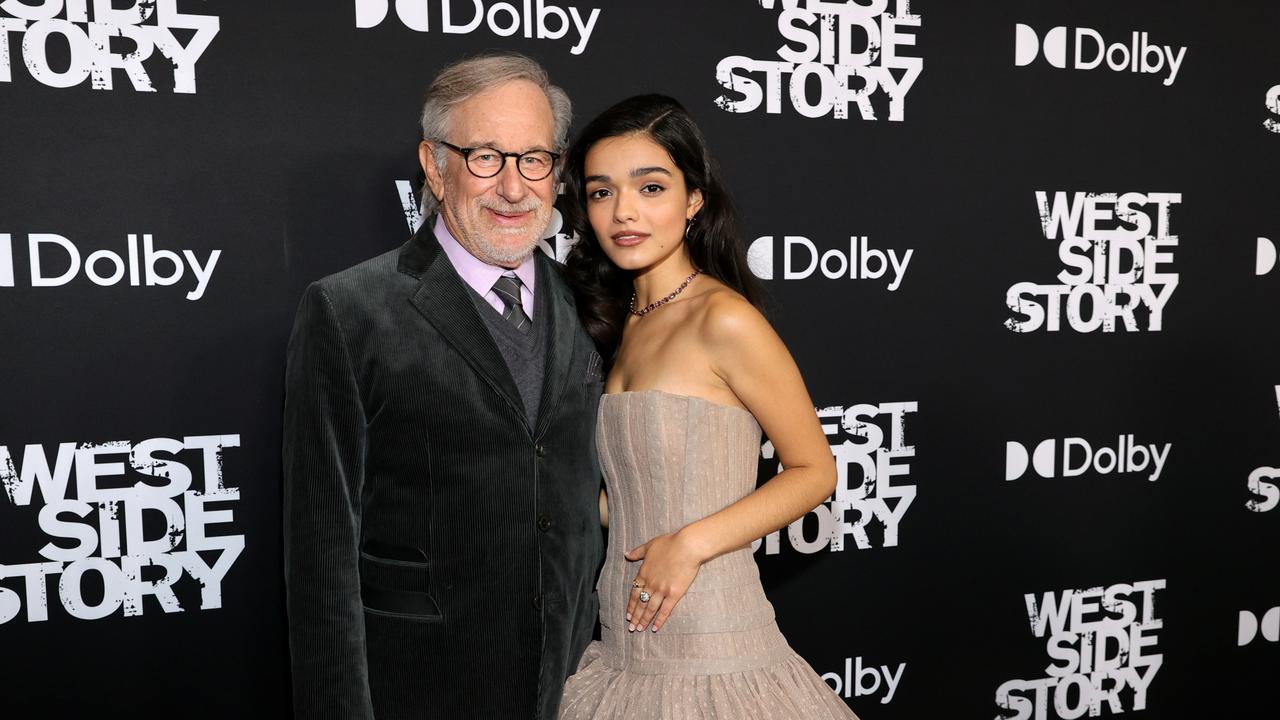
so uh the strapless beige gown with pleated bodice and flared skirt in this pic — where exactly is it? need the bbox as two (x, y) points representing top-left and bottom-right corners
(559, 391), (856, 720)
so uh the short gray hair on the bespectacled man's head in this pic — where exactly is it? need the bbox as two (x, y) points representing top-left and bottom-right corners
(421, 53), (573, 218)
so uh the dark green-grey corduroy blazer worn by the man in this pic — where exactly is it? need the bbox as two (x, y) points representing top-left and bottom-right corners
(284, 220), (603, 720)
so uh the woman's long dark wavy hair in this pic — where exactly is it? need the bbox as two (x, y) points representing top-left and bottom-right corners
(563, 95), (764, 365)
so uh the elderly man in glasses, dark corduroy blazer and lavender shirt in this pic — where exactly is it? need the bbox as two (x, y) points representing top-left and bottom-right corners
(284, 54), (603, 720)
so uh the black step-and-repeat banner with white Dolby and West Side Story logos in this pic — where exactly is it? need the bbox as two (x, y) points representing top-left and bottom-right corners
(0, 0), (1280, 720)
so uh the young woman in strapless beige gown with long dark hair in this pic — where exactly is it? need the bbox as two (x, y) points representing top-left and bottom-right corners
(559, 95), (854, 720)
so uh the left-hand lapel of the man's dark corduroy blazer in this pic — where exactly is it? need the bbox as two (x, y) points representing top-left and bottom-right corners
(399, 220), (541, 427)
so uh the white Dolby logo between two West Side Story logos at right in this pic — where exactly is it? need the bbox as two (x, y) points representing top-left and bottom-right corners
(1005, 434), (1172, 482)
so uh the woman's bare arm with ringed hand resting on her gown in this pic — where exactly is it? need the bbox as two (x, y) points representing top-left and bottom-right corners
(627, 293), (836, 630)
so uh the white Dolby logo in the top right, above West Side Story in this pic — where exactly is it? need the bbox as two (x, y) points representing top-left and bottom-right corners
(1014, 23), (1187, 87)
